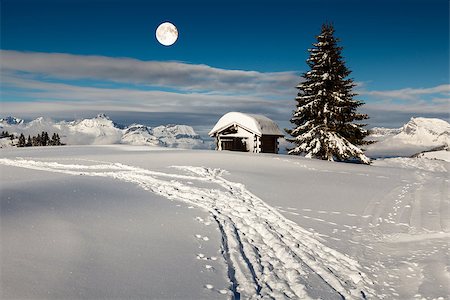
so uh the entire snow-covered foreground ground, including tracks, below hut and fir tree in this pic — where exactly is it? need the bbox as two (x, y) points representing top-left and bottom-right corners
(0, 145), (450, 299)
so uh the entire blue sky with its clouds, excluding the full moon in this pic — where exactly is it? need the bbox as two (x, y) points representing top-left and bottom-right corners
(0, 0), (449, 132)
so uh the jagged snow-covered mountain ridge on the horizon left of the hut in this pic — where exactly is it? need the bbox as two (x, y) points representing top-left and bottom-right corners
(0, 114), (210, 149)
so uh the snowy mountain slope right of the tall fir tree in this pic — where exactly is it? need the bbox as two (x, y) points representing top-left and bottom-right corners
(366, 118), (450, 157)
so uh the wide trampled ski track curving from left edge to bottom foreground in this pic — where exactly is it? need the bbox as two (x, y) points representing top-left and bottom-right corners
(0, 159), (374, 299)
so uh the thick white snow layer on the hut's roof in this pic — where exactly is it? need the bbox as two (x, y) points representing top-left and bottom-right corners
(209, 112), (284, 136)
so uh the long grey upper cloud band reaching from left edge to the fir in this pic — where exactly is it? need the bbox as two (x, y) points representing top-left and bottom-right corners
(0, 50), (300, 94)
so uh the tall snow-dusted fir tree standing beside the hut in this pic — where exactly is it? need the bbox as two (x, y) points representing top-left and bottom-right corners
(286, 24), (370, 164)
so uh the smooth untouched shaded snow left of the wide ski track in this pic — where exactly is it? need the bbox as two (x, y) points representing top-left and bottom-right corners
(0, 160), (229, 299)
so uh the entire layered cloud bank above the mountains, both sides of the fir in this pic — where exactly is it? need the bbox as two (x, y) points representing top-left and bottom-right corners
(0, 50), (450, 128)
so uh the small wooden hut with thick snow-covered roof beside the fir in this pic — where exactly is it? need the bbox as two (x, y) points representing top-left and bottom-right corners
(209, 112), (284, 153)
